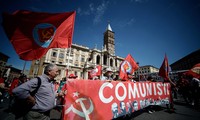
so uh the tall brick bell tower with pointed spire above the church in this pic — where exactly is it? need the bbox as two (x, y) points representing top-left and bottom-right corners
(103, 24), (115, 55)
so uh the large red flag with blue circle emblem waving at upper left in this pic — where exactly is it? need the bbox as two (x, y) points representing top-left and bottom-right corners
(3, 10), (75, 60)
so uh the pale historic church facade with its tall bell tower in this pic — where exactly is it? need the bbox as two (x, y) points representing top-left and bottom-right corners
(29, 24), (124, 79)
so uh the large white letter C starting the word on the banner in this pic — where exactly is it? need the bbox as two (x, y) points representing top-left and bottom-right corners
(99, 82), (113, 103)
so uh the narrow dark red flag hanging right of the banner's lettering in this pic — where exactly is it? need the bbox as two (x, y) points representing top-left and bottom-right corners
(158, 54), (169, 80)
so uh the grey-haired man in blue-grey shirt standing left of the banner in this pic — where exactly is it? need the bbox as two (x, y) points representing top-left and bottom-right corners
(12, 64), (59, 120)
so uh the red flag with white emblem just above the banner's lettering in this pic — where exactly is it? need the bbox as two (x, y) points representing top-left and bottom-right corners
(119, 54), (138, 80)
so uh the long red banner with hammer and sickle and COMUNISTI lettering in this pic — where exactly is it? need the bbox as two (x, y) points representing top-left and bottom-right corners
(63, 80), (171, 120)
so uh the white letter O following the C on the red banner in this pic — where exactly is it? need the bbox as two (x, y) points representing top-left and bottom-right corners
(115, 83), (127, 101)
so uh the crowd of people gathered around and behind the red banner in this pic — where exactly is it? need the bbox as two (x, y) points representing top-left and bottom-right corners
(0, 64), (200, 120)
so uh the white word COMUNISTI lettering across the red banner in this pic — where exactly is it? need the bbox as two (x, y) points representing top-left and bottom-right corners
(99, 82), (170, 103)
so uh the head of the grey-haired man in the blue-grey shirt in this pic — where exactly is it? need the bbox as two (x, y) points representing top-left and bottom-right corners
(44, 64), (59, 80)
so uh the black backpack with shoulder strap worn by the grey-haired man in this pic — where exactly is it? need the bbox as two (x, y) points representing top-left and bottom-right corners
(10, 77), (41, 119)
